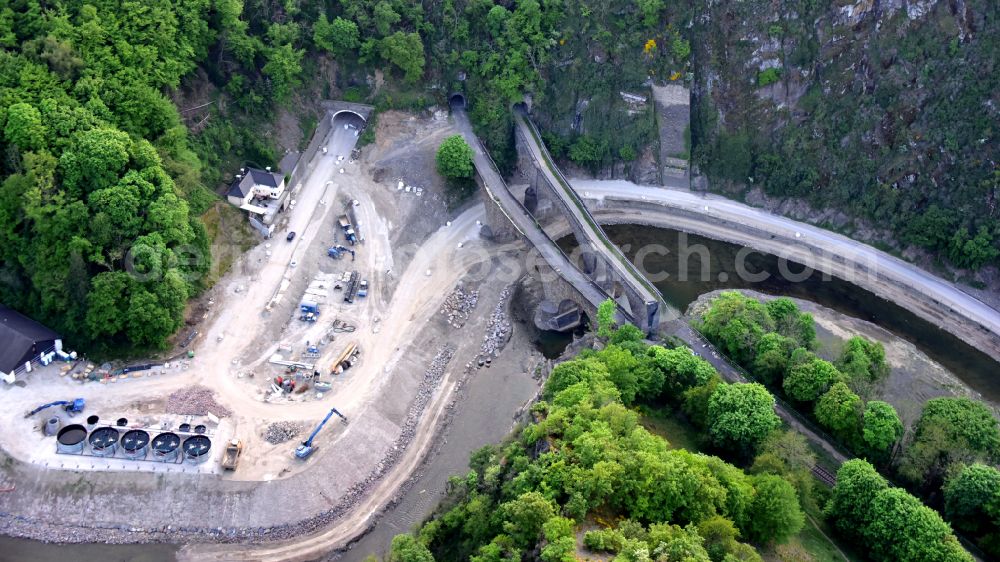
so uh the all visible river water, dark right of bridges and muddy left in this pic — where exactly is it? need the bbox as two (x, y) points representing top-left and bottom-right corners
(0, 225), (1000, 562)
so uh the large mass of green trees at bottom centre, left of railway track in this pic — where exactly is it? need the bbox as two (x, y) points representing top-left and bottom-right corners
(380, 304), (974, 562)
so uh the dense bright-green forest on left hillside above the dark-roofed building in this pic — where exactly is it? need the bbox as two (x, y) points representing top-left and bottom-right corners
(0, 0), (213, 346)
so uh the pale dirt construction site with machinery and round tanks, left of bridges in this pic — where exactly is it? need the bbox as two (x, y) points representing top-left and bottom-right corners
(0, 106), (544, 560)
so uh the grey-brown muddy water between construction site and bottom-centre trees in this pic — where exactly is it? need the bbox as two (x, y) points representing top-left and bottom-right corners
(329, 336), (538, 562)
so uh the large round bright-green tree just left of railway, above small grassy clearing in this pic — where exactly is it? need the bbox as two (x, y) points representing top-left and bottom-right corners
(708, 383), (781, 453)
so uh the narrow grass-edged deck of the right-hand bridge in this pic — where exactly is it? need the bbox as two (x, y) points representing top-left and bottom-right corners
(514, 109), (676, 320)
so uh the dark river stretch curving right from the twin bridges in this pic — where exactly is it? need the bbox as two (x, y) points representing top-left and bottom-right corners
(596, 225), (1000, 404)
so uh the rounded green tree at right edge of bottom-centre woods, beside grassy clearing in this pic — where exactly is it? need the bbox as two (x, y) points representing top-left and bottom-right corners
(749, 474), (805, 543)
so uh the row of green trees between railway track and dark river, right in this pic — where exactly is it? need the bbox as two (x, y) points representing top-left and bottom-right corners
(697, 291), (1000, 559)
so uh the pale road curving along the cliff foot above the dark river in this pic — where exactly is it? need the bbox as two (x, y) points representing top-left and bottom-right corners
(571, 179), (1000, 360)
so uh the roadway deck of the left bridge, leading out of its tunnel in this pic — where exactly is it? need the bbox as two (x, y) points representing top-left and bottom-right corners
(451, 105), (608, 316)
